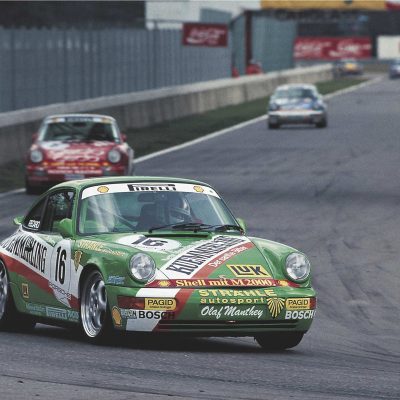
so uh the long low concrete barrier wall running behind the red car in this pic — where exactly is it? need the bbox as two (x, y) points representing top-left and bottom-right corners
(0, 65), (333, 164)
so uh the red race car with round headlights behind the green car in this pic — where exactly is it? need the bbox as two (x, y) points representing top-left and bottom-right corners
(25, 114), (134, 193)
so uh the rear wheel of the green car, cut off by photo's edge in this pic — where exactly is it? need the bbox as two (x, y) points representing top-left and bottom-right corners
(0, 260), (36, 332)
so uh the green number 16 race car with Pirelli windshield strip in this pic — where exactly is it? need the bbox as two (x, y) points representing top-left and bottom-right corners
(0, 177), (316, 349)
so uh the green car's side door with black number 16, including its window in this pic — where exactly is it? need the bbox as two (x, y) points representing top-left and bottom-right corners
(40, 189), (75, 308)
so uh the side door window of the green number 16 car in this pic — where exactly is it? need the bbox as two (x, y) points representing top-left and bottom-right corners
(41, 191), (74, 232)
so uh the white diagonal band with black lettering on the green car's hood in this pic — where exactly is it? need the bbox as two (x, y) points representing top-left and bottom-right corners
(166, 236), (247, 275)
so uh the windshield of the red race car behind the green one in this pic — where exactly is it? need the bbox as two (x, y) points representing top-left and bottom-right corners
(40, 118), (119, 142)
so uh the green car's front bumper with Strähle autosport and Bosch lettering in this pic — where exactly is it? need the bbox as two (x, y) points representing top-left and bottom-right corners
(107, 285), (316, 336)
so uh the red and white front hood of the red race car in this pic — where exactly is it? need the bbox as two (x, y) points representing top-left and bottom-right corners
(38, 141), (115, 162)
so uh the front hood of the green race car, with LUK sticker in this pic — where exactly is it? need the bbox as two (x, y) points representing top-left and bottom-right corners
(78, 232), (293, 286)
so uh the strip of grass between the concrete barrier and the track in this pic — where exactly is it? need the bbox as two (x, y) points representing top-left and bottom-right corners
(0, 78), (365, 192)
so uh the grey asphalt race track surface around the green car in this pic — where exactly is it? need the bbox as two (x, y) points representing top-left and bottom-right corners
(0, 78), (400, 400)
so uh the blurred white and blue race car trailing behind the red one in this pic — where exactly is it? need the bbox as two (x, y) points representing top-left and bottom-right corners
(267, 84), (328, 129)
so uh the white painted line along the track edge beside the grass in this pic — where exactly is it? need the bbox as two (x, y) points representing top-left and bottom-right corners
(0, 76), (383, 199)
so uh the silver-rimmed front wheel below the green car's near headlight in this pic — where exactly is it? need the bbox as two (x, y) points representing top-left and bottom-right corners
(80, 270), (112, 344)
